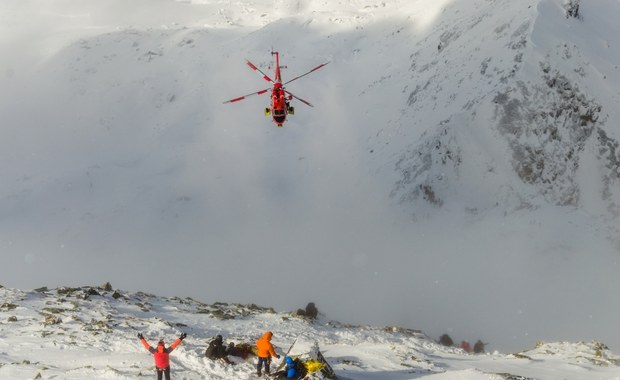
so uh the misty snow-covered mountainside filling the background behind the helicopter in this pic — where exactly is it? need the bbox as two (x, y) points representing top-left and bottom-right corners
(0, 0), (620, 349)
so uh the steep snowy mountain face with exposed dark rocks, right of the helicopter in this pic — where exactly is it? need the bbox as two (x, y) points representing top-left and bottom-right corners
(393, 1), (620, 217)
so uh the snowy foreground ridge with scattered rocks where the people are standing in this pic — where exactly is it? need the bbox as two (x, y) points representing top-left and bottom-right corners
(0, 284), (620, 380)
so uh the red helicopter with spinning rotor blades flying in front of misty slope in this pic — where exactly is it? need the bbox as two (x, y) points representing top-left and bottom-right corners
(224, 51), (329, 127)
